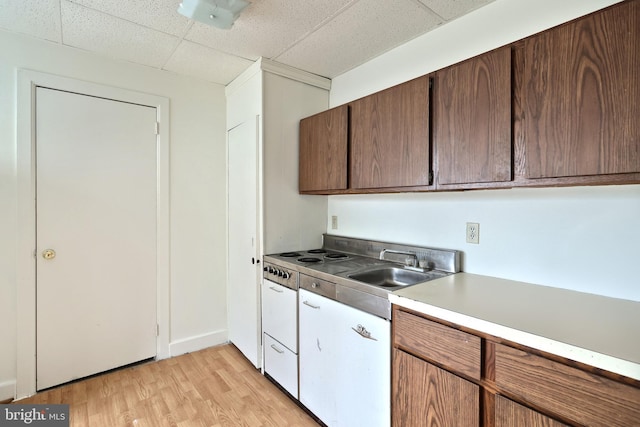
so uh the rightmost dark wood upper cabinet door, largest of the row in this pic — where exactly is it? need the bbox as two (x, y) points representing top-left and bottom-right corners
(520, 1), (640, 178)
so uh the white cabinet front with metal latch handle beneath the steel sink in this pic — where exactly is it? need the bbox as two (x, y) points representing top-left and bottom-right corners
(298, 289), (391, 427)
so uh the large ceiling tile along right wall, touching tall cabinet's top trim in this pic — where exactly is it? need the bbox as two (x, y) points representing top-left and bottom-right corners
(275, 0), (442, 78)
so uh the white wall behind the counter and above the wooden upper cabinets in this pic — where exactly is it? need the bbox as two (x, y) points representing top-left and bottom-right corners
(327, 0), (640, 303)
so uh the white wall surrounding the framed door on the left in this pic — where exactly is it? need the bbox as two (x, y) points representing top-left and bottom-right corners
(0, 31), (226, 400)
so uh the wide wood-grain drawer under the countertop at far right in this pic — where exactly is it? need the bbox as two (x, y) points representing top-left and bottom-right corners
(495, 344), (640, 426)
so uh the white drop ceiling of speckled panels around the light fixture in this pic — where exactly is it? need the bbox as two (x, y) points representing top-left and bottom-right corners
(0, 0), (494, 85)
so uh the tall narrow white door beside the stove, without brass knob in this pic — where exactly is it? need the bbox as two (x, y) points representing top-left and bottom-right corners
(227, 118), (262, 367)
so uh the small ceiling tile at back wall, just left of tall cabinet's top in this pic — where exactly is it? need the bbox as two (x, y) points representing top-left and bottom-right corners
(163, 40), (253, 85)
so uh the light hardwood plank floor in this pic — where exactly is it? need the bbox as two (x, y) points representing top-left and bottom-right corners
(15, 345), (318, 427)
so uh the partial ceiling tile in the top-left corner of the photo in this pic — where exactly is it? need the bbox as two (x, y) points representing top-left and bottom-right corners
(0, 0), (61, 43)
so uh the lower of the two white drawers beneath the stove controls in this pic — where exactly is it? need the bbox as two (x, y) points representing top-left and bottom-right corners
(264, 334), (298, 399)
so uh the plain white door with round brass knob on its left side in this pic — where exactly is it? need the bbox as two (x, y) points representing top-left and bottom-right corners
(36, 88), (157, 390)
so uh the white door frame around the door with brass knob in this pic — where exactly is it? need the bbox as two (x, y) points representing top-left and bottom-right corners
(15, 69), (170, 398)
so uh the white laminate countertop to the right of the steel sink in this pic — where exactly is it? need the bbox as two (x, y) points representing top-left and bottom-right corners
(389, 273), (640, 380)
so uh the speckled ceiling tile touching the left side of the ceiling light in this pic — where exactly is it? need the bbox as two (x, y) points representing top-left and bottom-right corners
(70, 0), (189, 37)
